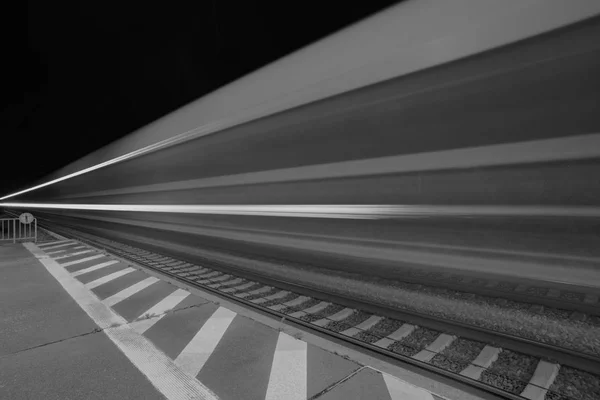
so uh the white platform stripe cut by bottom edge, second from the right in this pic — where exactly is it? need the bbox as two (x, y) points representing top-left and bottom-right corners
(265, 332), (308, 400)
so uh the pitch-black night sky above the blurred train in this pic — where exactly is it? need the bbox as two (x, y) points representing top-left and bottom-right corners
(0, 0), (404, 194)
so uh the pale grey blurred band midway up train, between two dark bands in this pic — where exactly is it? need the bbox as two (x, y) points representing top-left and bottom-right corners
(62, 133), (600, 199)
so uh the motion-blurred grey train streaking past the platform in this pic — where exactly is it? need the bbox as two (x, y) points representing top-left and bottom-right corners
(1, 0), (600, 288)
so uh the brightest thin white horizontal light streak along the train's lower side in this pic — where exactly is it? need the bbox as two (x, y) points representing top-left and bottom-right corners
(0, 203), (600, 219)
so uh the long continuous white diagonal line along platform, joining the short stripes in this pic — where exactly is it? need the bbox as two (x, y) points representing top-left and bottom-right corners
(23, 243), (218, 400)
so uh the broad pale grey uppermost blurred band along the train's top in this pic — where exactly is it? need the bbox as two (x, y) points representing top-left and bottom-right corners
(0, 0), (600, 201)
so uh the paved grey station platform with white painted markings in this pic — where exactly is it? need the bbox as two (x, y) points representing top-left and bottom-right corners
(0, 239), (474, 400)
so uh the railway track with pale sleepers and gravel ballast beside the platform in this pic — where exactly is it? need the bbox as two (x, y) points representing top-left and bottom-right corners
(39, 228), (600, 400)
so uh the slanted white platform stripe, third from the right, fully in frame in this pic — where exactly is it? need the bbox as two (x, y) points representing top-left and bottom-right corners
(175, 307), (236, 377)
